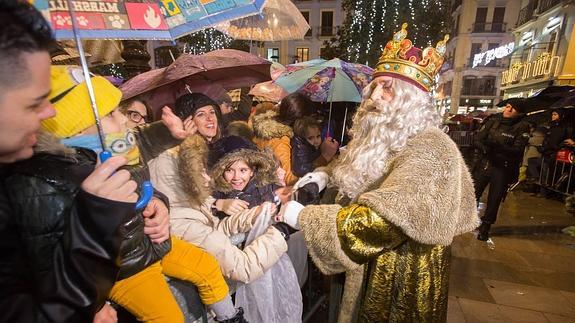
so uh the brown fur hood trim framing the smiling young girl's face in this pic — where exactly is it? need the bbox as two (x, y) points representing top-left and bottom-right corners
(210, 149), (280, 193)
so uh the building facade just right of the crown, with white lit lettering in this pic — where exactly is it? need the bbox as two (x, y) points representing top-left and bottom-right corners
(436, 0), (521, 114)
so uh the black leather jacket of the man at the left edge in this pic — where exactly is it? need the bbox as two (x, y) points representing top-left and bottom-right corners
(0, 136), (136, 322)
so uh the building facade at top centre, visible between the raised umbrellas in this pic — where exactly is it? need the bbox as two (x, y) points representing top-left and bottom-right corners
(251, 0), (344, 65)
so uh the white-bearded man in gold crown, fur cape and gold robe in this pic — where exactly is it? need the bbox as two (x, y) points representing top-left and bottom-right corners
(279, 24), (479, 322)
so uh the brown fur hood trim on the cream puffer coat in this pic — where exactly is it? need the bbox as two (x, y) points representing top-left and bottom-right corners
(178, 135), (211, 207)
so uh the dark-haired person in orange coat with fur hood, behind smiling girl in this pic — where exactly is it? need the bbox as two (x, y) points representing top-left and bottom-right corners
(252, 93), (313, 186)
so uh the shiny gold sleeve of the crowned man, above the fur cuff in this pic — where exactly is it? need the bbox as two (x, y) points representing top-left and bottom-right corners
(337, 204), (407, 264)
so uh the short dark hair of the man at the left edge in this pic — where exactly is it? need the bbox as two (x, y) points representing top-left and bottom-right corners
(0, 0), (55, 88)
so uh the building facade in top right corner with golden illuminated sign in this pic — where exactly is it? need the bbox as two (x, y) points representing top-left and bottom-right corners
(500, 0), (575, 98)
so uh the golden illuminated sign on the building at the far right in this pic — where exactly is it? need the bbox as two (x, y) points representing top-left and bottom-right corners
(501, 53), (562, 86)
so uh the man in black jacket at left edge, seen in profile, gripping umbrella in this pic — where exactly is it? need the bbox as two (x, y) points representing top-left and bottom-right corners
(0, 0), (143, 322)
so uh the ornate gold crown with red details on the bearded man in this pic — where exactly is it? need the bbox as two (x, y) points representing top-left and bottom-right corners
(373, 23), (449, 92)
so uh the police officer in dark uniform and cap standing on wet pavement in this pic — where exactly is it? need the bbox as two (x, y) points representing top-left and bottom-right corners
(473, 99), (529, 241)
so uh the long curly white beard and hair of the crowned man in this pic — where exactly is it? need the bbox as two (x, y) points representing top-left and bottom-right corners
(331, 79), (440, 202)
